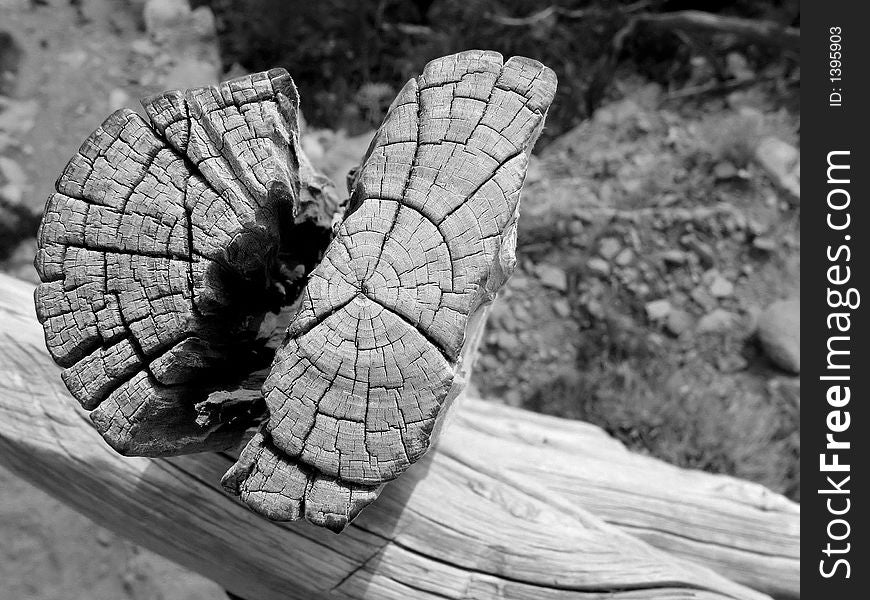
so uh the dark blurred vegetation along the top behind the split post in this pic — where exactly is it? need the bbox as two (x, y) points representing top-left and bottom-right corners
(195, 0), (800, 141)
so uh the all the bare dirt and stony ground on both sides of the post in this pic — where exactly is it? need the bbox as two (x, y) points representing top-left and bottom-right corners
(0, 0), (800, 600)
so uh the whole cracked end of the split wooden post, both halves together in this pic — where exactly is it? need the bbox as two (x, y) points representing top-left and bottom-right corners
(36, 51), (556, 531)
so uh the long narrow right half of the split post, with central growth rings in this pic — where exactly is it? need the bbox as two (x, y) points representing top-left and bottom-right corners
(224, 51), (556, 531)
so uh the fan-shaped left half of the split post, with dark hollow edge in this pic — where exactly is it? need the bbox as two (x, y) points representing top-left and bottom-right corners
(35, 69), (337, 456)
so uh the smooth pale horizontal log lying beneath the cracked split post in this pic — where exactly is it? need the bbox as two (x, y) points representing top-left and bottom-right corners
(0, 275), (799, 600)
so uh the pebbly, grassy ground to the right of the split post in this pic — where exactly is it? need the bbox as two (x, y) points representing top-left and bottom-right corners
(473, 82), (800, 499)
